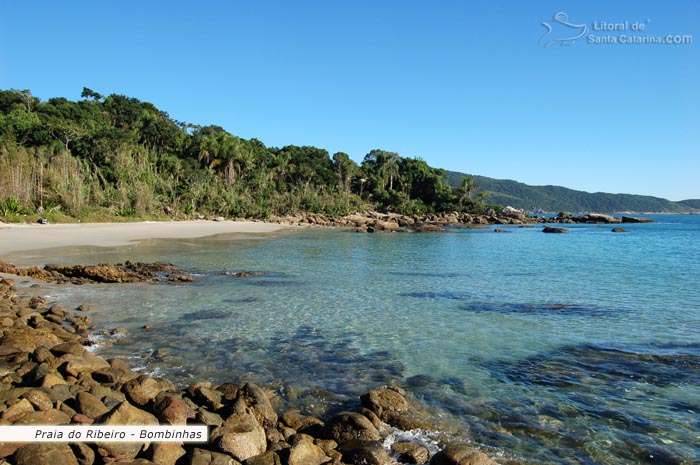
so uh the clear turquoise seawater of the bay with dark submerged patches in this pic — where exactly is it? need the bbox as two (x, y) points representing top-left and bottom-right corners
(10, 216), (700, 464)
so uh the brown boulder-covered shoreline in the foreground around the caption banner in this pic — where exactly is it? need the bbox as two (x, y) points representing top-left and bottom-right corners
(0, 278), (496, 465)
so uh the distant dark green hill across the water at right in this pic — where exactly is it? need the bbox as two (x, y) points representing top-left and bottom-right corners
(447, 171), (700, 213)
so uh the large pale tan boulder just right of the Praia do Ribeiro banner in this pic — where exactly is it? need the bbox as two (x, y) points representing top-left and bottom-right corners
(211, 406), (267, 461)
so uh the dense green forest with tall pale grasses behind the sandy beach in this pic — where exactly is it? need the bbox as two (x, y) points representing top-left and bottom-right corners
(0, 88), (486, 221)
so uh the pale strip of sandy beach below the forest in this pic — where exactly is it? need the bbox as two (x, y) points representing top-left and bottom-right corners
(0, 221), (290, 257)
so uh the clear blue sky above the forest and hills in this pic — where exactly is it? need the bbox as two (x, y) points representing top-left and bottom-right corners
(0, 0), (700, 200)
